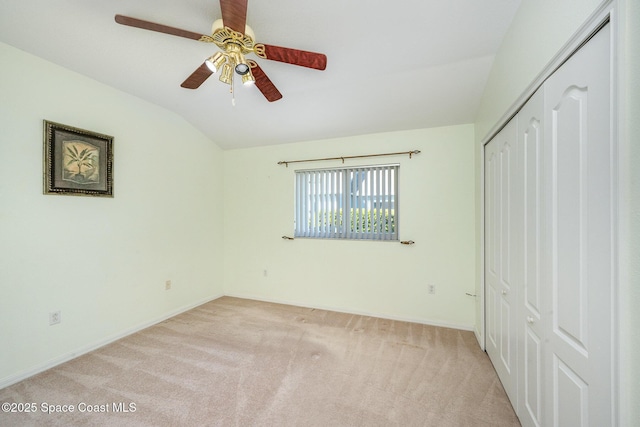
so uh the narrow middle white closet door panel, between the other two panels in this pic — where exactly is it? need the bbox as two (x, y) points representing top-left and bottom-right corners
(513, 89), (548, 427)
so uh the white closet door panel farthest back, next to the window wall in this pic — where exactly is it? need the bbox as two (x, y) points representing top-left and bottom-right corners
(485, 120), (517, 407)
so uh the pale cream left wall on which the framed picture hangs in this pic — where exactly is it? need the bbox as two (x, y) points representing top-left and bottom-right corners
(0, 44), (223, 387)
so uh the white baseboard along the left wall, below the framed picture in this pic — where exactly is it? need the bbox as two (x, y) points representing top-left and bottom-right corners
(0, 295), (223, 389)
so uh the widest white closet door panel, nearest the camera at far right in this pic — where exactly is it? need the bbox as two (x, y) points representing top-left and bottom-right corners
(543, 25), (613, 427)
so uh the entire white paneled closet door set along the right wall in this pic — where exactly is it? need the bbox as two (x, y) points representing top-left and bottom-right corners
(484, 24), (616, 427)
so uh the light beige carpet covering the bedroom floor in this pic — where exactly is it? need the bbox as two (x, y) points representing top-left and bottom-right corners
(0, 297), (520, 427)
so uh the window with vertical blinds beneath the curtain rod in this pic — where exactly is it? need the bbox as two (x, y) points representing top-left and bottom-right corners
(294, 164), (400, 240)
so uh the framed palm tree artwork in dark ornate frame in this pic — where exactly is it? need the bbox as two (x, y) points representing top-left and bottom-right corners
(44, 120), (113, 197)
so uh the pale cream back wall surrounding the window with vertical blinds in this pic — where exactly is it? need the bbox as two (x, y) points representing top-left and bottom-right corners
(224, 125), (475, 329)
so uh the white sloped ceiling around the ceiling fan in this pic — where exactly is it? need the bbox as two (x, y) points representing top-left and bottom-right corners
(0, 0), (520, 149)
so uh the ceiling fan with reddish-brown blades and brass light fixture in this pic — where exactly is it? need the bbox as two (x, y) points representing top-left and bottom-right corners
(115, 0), (327, 102)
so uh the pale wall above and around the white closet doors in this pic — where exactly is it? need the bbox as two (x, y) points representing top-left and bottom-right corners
(475, 0), (640, 426)
